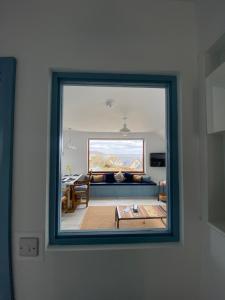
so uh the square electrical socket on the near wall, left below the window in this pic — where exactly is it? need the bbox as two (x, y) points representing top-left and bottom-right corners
(19, 237), (39, 257)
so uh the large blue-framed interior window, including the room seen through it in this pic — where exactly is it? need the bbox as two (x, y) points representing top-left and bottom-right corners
(49, 72), (179, 245)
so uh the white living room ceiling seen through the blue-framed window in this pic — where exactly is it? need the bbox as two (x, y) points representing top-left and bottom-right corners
(63, 86), (165, 136)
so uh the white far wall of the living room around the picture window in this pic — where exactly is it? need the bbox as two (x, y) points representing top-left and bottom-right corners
(62, 130), (166, 182)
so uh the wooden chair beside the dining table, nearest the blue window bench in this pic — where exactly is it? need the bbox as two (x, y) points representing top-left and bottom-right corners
(73, 173), (91, 208)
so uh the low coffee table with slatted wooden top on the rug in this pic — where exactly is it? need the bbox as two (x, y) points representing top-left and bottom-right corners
(115, 205), (167, 228)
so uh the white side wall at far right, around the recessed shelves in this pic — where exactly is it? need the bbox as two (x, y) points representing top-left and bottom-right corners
(197, 0), (225, 300)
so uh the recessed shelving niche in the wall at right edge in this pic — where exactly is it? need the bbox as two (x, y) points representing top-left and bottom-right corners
(205, 35), (225, 232)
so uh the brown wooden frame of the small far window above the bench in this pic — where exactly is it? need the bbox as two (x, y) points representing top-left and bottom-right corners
(87, 137), (145, 174)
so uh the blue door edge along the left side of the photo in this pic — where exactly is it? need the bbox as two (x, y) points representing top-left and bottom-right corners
(0, 57), (16, 300)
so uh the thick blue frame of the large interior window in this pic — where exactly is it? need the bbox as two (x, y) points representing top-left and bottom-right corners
(49, 72), (180, 245)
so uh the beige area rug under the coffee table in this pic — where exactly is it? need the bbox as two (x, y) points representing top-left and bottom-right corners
(80, 205), (166, 230)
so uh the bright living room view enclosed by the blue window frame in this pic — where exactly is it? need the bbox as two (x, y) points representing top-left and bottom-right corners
(60, 85), (168, 231)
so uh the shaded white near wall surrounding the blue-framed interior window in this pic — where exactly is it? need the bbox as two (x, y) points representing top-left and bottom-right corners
(0, 0), (200, 300)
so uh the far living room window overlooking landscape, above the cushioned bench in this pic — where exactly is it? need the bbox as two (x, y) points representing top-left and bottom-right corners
(88, 139), (144, 173)
